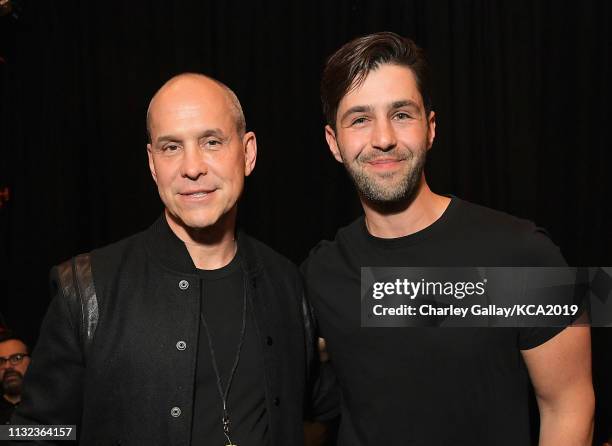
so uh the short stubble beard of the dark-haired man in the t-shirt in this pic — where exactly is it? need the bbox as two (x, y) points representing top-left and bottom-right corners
(344, 147), (427, 207)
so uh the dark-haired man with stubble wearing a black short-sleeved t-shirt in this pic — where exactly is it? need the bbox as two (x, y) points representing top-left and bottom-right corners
(302, 33), (594, 446)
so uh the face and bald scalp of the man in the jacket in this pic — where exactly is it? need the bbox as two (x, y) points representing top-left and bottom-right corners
(147, 75), (257, 238)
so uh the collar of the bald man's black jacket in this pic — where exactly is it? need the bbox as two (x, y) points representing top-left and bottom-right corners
(145, 213), (261, 276)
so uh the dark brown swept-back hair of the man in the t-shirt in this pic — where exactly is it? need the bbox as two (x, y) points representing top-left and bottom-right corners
(321, 32), (431, 129)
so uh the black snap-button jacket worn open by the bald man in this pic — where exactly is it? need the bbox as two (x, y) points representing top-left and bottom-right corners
(12, 216), (315, 446)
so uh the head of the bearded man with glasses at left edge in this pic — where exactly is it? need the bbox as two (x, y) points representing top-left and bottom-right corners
(0, 332), (30, 424)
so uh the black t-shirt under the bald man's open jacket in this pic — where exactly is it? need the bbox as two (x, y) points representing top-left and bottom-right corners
(191, 253), (269, 446)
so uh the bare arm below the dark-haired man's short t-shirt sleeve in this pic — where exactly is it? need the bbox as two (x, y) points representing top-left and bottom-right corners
(522, 327), (595, 446)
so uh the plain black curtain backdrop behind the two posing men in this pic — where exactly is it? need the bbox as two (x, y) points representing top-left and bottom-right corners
(0, 0), (612, 442)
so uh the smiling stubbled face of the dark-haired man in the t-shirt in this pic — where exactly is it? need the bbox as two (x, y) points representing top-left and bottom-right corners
(325, 64), (435, 203)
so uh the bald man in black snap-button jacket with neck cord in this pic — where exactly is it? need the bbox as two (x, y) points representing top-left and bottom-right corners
(13, 73), (316, 446)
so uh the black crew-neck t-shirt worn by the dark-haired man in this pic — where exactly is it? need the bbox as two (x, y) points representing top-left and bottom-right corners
(302, 198), (565, 446)
